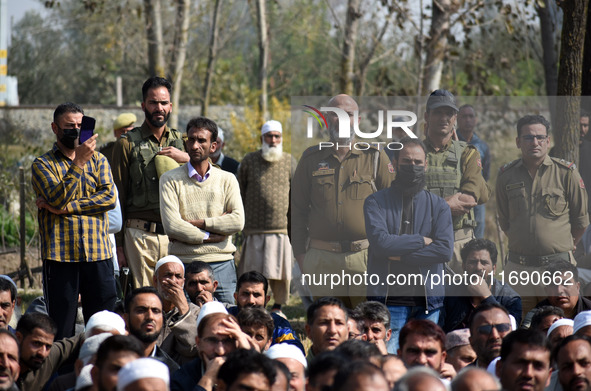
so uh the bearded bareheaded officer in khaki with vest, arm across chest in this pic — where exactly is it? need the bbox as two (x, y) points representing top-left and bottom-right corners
(111, 77), (189, 288)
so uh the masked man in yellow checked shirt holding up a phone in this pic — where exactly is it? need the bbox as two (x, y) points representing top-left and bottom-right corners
(32, 102), (116, 340)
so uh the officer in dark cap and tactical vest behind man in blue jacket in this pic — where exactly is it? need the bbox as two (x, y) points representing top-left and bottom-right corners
(425, 90), (490, 273)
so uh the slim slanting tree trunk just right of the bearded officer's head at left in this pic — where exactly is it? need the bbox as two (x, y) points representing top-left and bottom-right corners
(169, 0), (191, 129)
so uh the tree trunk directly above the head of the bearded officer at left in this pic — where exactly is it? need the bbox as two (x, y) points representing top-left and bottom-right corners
(144, 0), (165, 77)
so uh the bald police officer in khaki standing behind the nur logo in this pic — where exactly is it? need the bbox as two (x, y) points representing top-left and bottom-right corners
(291, 95), (394, 308)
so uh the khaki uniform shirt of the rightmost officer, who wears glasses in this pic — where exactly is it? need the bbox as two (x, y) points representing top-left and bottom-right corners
(496, 156), (589, 255)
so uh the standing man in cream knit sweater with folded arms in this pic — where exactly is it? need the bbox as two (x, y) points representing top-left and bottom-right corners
(160, 117), (244, 304)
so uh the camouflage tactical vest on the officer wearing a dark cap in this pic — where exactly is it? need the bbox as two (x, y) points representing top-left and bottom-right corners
(425, 140), (476, 231)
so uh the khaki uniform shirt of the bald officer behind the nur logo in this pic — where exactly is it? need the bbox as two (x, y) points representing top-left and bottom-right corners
(291, 146), (394, 255)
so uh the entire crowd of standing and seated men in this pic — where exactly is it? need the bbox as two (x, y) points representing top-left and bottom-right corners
(19, 77), (591, 391)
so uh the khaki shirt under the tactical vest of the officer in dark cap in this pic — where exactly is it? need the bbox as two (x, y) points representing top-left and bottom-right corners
(425, 138), (491, 205)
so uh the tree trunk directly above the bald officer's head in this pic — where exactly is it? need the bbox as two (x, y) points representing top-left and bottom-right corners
(340, 0), (361, 95)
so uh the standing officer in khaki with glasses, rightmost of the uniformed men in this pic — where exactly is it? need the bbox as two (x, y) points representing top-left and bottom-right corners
(496, 115), (589, 314)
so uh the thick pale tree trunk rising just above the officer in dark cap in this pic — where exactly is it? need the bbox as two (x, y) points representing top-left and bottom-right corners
(422, 0), (459, 95)
